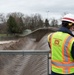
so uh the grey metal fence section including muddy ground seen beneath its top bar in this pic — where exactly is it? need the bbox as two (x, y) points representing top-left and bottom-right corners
(0, 50), (49, 75)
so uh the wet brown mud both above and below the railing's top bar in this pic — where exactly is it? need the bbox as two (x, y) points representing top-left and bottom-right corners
(0, 27), (57, 75)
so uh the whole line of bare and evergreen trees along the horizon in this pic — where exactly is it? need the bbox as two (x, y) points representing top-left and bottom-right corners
(0, 12), (58, 34)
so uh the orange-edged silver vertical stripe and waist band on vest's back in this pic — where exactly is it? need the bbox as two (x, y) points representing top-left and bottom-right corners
(52, 35), (74, 74)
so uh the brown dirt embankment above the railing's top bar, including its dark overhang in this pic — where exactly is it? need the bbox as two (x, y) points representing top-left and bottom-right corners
(1, 27), (57, 50)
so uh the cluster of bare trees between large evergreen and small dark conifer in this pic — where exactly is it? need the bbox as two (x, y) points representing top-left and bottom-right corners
(24, 14), (43, 30)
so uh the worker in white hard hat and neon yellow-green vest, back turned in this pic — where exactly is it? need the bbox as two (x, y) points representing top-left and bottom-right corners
(48, 14), (74, 75)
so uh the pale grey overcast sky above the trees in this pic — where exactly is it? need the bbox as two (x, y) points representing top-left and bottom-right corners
(0, 0), (74, 18)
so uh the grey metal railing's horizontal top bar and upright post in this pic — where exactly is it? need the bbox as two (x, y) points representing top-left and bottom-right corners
(0, 50), (50, 75)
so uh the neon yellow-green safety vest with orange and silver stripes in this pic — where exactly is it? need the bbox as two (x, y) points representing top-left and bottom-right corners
(48, 32), (74, 74)
